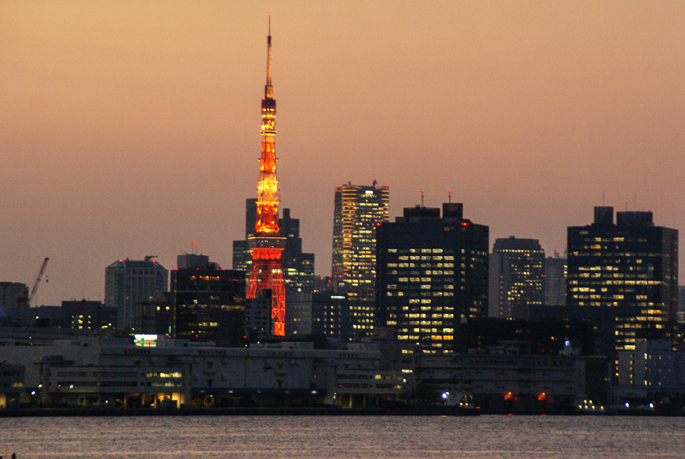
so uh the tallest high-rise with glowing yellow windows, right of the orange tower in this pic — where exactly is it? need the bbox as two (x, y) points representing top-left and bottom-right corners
(332, 180), (390, 303)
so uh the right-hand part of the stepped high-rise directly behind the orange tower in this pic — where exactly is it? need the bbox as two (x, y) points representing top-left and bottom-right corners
(279, 209), (314, 292)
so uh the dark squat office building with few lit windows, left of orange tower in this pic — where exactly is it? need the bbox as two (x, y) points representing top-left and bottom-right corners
(171, 255), (245, 346)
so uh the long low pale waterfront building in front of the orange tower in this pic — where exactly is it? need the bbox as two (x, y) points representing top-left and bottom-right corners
(0, 337), (404, 407)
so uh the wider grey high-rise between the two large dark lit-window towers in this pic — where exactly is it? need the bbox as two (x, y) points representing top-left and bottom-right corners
(488, 236), (545, 318)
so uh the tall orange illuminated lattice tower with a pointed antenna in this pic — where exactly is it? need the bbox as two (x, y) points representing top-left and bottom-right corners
(247, 15), (285, 336)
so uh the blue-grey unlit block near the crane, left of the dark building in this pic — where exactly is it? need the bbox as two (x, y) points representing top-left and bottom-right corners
(105, 256), (169, 331)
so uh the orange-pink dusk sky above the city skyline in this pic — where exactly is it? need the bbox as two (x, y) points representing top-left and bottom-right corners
(0, 0), (685, 305)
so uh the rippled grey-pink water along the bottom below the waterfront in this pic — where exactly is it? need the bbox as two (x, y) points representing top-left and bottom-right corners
(0, 416), (685, 459)
